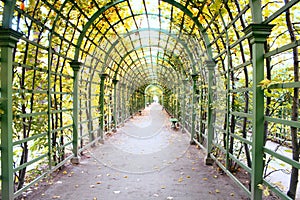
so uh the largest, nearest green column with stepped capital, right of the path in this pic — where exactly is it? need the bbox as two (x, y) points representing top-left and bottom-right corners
(244, 24), (273, 200)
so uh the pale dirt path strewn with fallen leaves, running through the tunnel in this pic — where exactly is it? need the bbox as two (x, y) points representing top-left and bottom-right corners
(33, 104), (247, 200)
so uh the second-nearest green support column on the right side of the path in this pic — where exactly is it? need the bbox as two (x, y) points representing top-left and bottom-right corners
(205, 61), (216, 165)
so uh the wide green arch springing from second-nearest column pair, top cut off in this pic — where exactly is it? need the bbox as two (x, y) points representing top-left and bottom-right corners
(74, 0), (212, 60)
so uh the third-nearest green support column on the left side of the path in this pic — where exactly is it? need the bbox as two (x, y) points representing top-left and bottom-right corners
(97, 74), (108, 143)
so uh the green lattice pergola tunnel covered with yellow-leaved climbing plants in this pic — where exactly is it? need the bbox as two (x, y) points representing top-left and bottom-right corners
(0, 0), (300, 200)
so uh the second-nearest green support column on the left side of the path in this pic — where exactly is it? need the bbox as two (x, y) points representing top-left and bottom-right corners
(70, 61), (82, 164)
